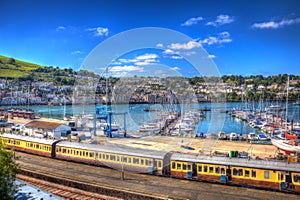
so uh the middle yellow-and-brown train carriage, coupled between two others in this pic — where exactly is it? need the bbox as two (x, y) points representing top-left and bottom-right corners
(56, 142), (163, 174)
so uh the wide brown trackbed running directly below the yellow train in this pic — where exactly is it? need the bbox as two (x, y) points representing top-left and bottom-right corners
(17, 152), (299, 200)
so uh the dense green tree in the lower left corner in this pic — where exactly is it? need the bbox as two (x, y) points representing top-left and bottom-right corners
(0, 138), (19, 200)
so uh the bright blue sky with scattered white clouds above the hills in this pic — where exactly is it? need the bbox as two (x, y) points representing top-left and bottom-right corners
(0, 0), (300, 76)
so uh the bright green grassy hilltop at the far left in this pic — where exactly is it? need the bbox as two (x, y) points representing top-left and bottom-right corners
(0, 56), (44, 78)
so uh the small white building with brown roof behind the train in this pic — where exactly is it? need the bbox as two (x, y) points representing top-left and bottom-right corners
(25, 120), (71, 138)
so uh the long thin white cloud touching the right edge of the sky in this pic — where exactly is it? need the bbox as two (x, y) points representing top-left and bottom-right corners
(252, 17), (300, 29)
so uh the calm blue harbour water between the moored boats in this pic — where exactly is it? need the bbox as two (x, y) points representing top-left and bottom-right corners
(3, 102), (300, 133)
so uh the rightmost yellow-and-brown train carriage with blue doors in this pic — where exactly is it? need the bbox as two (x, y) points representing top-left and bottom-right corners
(171, 153), (300, 192)
